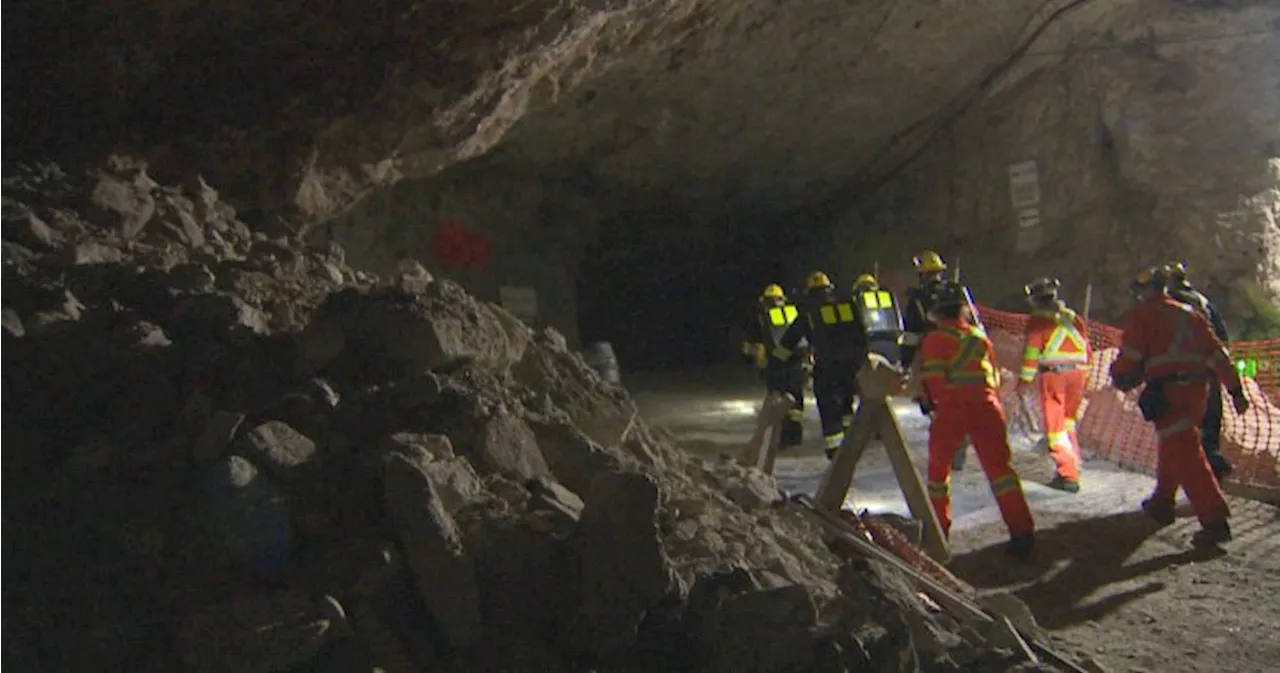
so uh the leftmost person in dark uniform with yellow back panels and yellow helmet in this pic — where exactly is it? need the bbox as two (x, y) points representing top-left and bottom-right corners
(742, 284), (805, 448)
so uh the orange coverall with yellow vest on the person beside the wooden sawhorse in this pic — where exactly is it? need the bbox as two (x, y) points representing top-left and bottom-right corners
(920, 320), (1036, 537)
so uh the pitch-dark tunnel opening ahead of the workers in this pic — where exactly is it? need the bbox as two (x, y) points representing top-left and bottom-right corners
(577, 212), (804, 371)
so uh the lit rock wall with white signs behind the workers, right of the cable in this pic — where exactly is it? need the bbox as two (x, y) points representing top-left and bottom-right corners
(810, 3), (1280, 334)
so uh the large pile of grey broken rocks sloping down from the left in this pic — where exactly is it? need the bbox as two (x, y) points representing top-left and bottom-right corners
(0, 159), (1049, 673)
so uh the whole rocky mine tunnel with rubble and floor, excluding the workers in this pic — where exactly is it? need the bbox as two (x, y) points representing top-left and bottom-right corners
(0, 0), (1280, 673)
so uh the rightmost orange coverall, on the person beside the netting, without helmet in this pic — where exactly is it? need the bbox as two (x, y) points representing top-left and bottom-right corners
(1111, 294), (1240, 523)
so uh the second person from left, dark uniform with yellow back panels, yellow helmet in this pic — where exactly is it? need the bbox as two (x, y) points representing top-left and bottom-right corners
(773, 271), (867, 459)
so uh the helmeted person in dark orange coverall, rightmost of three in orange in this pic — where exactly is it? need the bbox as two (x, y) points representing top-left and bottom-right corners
(1111, 267), (1249, 546)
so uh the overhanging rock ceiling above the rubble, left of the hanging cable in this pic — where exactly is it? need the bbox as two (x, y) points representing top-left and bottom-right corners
(0, 0), (1070, 243)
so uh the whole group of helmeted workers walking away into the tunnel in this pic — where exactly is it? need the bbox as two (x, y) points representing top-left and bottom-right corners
(742, 251), (1248, 558)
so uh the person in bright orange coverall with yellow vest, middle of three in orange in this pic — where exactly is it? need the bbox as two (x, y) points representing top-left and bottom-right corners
(1018, 278), (1089, 493)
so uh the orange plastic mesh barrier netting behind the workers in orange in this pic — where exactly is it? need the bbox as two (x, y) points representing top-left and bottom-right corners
(978, 307), (1280, 495)
